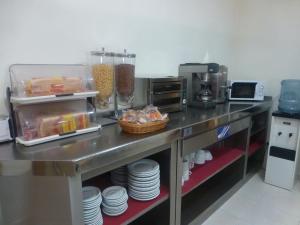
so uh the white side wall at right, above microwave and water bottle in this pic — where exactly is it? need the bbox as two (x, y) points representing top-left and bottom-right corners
(229, 0), (300, 108)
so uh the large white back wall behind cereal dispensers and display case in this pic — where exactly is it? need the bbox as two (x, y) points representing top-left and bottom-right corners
(0, 0), (236, 114)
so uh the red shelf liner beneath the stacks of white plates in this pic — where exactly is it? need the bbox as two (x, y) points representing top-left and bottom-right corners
(102, 185), (169, 225)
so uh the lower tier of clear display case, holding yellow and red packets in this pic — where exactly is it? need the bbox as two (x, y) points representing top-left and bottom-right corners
(15, 100), (100, 146)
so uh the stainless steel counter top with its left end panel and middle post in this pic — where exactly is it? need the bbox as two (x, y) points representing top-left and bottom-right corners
(0, 98), (272, 225)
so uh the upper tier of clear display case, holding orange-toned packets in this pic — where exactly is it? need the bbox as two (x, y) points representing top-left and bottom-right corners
(9, 64), (98, 104)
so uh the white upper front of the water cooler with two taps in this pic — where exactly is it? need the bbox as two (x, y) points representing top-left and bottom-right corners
(271, 117), (299, 149)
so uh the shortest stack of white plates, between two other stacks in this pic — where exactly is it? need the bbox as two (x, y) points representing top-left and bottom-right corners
(102, 186), (128, 216)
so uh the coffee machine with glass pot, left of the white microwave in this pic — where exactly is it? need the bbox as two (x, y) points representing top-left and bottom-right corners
(179, 63), (228, 108)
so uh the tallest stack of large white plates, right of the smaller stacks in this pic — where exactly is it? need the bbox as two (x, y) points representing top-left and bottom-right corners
(128, 159), (160, 201)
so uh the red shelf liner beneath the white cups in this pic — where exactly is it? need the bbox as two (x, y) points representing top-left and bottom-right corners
(182, 148), (243, 195)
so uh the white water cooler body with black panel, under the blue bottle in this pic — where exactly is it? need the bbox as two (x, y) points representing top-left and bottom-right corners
(265, 112), (300, 189)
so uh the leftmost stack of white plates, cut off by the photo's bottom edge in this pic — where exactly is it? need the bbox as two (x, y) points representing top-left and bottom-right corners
(82, 186), (103, 225)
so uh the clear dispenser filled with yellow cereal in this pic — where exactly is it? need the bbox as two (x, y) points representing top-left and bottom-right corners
(91, 48), (114, 109)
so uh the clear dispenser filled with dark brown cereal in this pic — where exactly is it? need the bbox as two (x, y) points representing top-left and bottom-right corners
(115, 50), (136, 107)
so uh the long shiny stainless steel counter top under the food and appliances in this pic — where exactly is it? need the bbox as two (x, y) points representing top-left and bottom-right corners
(0, 98), (272, 177)
